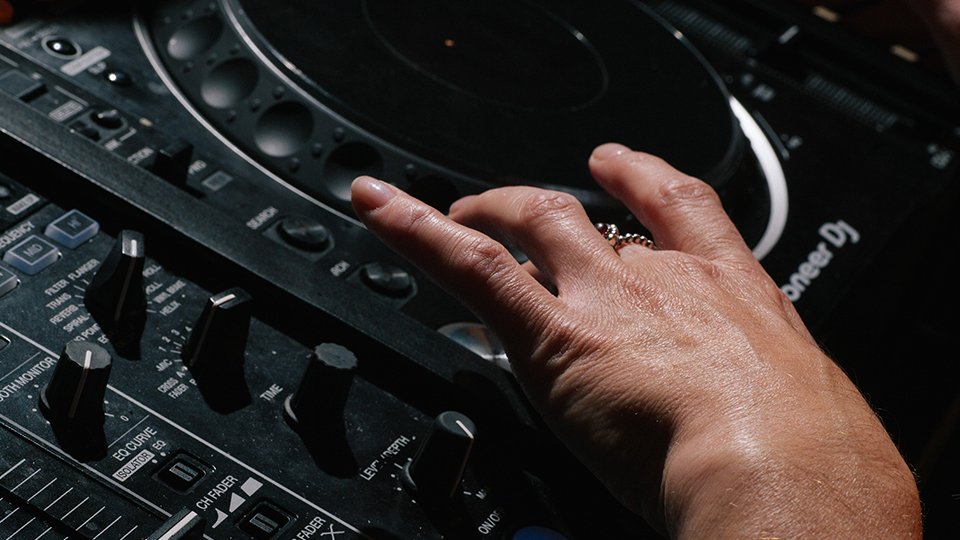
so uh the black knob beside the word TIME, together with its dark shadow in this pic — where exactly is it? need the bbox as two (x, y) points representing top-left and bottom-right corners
(283, 343), (359, 478)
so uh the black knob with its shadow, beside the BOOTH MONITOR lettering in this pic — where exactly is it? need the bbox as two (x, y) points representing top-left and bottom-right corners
(40, 341), (112, 461)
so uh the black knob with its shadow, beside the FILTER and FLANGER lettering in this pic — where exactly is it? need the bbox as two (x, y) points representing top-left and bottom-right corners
(83, 231), (147, 359)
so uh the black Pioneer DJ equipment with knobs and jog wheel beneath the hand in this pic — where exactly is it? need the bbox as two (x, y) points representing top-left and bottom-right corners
(0, 0), (960, 540)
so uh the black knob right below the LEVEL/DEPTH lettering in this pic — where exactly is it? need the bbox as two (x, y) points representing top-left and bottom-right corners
(402, 411), (477, 500)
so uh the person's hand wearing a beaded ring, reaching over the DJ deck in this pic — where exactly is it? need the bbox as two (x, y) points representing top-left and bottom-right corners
(353, 144), (920, 538)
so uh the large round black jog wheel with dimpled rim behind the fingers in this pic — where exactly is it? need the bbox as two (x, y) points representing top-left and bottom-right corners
(149, 0), (786, 250)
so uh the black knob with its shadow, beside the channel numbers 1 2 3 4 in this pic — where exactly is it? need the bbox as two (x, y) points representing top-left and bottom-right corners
(182, 288), (253, 414)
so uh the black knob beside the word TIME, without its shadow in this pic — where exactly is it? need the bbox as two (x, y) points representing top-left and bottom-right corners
(284, 343), (357, 431)
